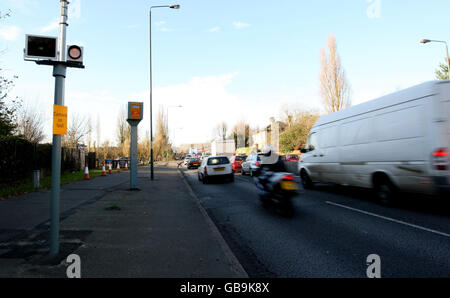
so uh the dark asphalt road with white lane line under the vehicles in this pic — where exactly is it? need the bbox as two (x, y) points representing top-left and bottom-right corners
(183, 169), (450, 278)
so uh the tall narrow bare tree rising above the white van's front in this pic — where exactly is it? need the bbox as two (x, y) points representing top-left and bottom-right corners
(320, 35), (351, 113)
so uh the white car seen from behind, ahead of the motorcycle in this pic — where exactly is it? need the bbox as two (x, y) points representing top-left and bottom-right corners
(198, 156), (234, 184)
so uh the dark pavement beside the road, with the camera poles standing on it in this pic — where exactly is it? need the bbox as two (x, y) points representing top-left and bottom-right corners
(0, 163), (248, 278)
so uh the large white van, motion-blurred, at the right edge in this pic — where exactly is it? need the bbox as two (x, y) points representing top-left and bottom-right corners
(298, 80), (450, 204)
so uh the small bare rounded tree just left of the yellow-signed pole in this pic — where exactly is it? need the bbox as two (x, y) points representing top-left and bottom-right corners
(16, 106), (45, 144)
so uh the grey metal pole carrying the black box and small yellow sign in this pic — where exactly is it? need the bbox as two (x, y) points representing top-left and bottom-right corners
(50, 0), (69, 255)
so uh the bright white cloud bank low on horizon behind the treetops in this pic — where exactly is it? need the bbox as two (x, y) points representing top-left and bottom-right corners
(13, 72), (310, 144)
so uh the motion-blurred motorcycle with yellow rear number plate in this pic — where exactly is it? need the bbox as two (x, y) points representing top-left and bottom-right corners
(254, 170), (299, 217)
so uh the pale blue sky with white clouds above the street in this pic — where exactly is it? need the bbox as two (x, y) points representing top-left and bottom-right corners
(0, 0), (450, 143)
